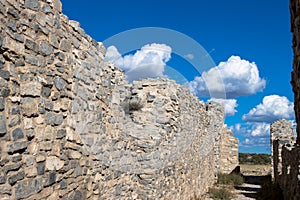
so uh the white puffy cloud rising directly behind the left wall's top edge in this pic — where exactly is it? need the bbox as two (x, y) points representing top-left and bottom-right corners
(105, 43), (172, 81)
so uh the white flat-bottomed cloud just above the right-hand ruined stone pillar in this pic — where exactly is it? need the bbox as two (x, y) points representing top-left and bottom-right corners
(243, 95), (295, 123)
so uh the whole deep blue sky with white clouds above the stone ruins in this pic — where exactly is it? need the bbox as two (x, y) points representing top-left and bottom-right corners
(62, 0), (294, 153)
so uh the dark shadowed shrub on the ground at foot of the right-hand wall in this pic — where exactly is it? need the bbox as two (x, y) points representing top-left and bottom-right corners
(257, 181), (283, 200)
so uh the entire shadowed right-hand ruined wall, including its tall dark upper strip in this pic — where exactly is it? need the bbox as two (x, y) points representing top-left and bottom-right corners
(271, 0), (300, 199)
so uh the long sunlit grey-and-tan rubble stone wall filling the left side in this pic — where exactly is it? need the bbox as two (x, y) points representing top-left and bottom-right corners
(0, 0), (238, 200)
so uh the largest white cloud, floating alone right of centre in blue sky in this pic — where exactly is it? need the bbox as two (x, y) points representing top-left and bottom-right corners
(187, 56), (266, 98)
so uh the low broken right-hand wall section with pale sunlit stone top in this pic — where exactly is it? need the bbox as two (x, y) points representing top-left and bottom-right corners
(270, 120), (300, 199)
